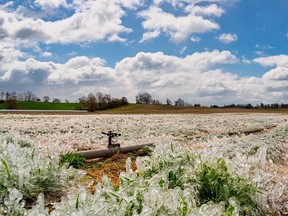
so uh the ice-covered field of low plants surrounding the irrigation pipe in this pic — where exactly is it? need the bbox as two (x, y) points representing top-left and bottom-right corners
(0, 114), (288, 215)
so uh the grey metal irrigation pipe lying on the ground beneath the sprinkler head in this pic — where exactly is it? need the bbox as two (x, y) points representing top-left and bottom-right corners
(76, 143), (155, 159)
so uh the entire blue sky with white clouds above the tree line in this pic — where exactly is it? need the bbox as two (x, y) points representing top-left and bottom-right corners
(0, 0), (288, 105)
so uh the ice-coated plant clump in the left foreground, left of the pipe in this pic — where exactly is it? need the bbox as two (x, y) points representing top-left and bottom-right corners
(0, 134), (84, 215)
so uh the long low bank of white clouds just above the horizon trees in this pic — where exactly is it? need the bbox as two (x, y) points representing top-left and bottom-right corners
(0, 50), (288, 105)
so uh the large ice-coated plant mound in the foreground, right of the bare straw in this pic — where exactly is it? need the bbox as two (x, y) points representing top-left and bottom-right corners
(26, 141), (272, 216)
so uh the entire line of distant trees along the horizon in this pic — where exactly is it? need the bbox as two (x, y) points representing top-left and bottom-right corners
(0, 91), (288, 112)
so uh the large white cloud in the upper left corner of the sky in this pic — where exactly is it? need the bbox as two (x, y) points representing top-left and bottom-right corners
(0, 0), (141, 46)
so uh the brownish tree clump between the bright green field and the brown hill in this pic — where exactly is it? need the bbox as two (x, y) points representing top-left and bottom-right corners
(79, 92), (129, 112)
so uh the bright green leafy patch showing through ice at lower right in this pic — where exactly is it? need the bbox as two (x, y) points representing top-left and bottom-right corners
(196, 159), (262, 215)
